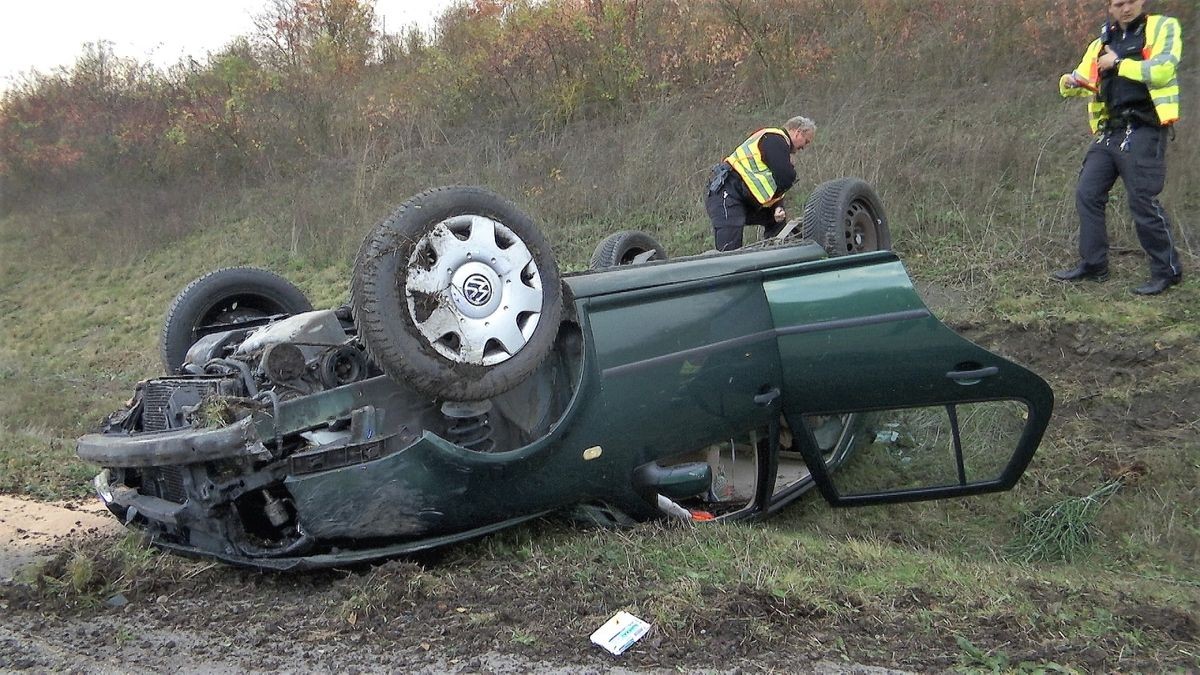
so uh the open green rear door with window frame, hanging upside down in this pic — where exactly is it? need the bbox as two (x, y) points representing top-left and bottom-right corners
(763, 252), (1054, 506)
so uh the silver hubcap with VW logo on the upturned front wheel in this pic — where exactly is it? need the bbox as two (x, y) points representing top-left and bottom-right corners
(406, 215), (542, 365)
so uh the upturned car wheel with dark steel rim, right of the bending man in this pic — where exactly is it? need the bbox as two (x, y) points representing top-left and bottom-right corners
(802, 178), (892, 256)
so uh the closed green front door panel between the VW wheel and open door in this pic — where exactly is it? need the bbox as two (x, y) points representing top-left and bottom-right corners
(586, 258), (780, 456)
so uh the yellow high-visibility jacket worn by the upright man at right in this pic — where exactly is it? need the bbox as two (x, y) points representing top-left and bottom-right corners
(1058, 14), (1183, 133)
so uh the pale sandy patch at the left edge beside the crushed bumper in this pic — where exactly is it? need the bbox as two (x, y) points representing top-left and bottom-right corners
(0, 495), (121, 581)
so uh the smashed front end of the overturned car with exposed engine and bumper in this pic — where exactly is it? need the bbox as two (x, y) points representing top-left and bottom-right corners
(78, 311), (383, 558)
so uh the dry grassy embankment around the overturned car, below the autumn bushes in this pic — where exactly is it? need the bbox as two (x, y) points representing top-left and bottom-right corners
(0, 2), (1200, 669)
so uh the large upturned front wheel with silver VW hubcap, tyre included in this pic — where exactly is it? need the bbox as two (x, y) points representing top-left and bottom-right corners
(350, 187), (563, 401)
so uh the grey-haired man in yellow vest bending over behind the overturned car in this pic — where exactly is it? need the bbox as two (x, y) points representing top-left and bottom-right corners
(704, 117), (817, 251)
